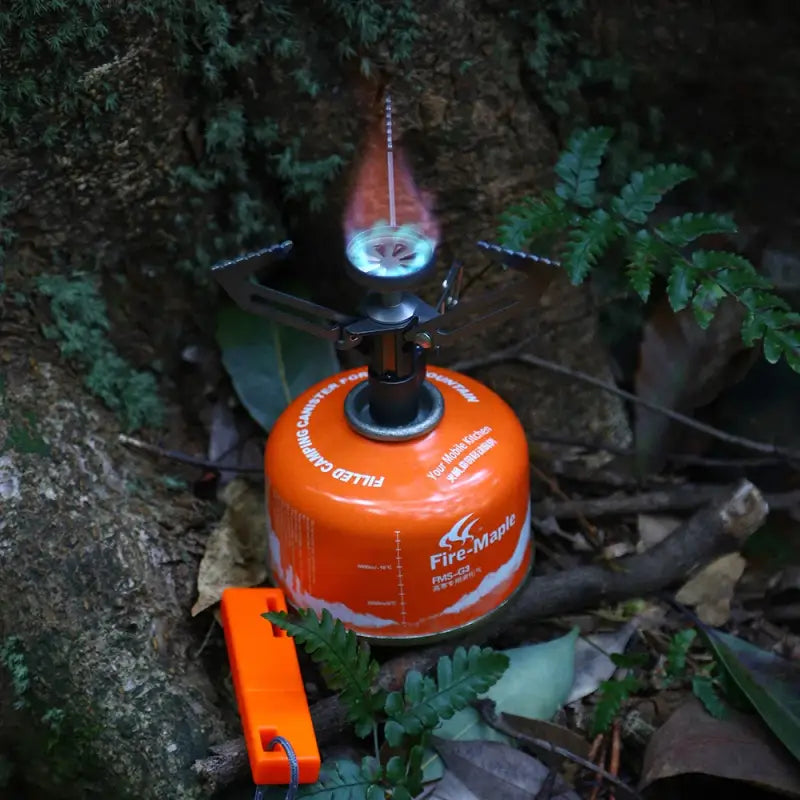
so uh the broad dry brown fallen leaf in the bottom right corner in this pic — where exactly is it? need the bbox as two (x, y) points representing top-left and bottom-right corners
(639, 698), (800, 797)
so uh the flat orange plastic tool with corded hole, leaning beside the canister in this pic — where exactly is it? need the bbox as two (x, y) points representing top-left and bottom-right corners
(222, 588), (320, 786)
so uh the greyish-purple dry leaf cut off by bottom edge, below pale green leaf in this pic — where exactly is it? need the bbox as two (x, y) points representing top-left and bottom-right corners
(435, 739), (580, 800)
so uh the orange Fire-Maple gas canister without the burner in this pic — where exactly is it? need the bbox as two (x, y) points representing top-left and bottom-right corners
(265, 367), (532, 642)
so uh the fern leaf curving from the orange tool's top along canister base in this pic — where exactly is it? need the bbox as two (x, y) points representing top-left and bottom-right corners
(261, 609), (384, 737)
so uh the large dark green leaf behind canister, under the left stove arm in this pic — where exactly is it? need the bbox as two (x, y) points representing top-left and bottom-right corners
(217, 306), (338, 431)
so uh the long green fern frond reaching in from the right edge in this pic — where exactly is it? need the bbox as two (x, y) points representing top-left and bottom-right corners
(499, 128), (800, 372)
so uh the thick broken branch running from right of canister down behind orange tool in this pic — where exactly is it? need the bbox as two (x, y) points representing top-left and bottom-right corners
(194, 481), (768, 788)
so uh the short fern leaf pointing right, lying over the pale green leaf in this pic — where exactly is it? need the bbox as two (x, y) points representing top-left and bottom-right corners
(384, 646), (508, 736)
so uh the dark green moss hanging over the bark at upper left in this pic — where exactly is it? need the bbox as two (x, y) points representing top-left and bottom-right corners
(0, 0), (419, 282)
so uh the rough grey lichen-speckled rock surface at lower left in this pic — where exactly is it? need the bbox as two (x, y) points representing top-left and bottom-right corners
(0, 347), (231, 800)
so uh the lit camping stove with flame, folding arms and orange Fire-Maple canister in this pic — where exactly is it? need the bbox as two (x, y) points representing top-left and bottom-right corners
(214, 98), (552, 643)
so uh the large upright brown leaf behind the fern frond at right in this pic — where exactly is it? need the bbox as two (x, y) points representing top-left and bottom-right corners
(634, 297), (758, 471)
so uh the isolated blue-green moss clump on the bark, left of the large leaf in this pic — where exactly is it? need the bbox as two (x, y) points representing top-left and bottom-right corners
(37, 273), (163, 431)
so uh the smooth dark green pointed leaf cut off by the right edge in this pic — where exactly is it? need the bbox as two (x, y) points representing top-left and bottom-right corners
(703, 628), (800, 759)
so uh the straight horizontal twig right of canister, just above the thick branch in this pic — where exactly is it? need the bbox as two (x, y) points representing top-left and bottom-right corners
(535, 484), (800, 520)
